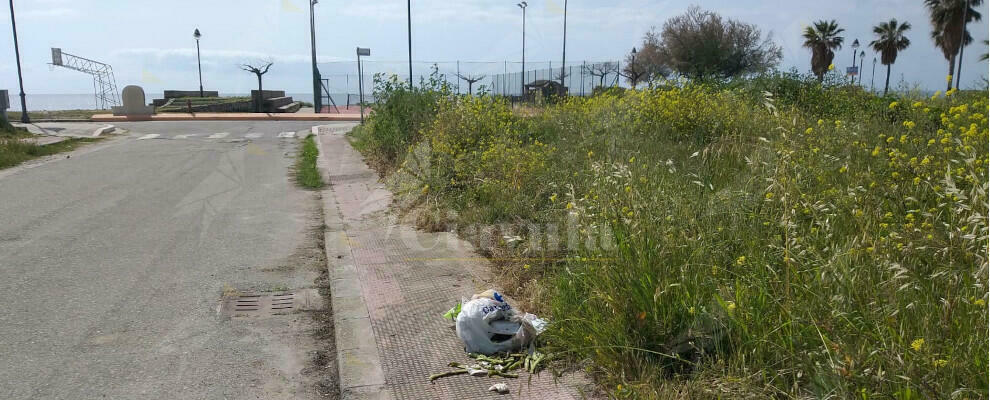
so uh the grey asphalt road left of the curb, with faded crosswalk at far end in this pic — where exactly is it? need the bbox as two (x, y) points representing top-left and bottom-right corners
(0, 122), (348, 399)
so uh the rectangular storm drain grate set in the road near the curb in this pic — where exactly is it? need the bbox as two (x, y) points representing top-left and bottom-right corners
(220, 289), (323, 317)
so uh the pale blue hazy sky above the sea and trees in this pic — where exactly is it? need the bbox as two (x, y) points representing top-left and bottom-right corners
(0, 0), (990, 96)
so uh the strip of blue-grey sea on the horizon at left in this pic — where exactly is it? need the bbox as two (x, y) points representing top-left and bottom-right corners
(3, 91), (357, 111)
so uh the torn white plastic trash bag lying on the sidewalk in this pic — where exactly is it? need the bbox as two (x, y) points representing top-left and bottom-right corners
(460, 290), (546, 354)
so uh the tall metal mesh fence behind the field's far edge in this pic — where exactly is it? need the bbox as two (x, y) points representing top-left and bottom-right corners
(318, 60), (628, 102)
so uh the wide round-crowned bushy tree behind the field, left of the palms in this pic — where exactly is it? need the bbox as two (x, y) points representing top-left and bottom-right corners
(643, 6), (783, 78)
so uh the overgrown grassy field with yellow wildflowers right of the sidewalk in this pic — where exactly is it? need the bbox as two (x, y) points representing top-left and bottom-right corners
(353, 76), (990, 399)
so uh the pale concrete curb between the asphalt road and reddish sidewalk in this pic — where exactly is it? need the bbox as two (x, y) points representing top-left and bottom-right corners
(312, 127), (392, 400)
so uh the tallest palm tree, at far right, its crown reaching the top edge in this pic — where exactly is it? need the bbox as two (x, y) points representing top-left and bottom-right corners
(924, 0), (983, 90)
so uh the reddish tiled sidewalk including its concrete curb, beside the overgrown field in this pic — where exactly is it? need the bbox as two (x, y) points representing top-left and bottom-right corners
(318, 126), (589, 400)
